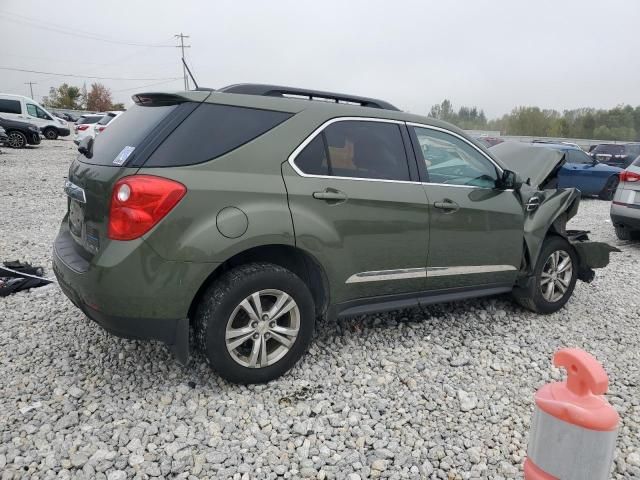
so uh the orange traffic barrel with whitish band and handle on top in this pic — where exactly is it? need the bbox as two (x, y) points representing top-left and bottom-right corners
(524, 348), (620, 480)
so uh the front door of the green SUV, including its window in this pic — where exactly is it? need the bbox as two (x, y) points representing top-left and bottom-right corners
(411, 126), (524, 289)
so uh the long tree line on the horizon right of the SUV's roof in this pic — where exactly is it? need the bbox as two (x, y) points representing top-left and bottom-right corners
(429, 100), (640, 141)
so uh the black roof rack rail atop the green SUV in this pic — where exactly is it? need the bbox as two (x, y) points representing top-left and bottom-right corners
(218, 83), (399, 110)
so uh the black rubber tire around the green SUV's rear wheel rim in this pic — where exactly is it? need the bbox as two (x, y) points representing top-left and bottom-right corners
(195, 262), (315, 384)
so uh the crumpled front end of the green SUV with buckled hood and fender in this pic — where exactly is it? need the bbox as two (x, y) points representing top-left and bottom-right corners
(491, 142), (620, 290)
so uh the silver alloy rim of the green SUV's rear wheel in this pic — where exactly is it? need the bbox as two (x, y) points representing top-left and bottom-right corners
(225, 289), (300, 368)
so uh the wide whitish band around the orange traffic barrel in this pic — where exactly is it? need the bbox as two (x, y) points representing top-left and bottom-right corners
(527, 407), (618, 480)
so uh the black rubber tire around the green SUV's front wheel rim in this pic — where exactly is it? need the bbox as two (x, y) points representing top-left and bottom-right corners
(513, 235), (578, 314)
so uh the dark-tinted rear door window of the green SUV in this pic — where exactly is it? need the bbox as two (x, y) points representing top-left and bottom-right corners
(295, 120), (410, 181)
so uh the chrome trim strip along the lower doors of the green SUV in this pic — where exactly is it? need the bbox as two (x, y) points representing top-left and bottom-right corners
(345, 265), (518, 283)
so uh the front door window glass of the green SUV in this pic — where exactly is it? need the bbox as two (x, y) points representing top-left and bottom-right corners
(414, 127), (498, 188)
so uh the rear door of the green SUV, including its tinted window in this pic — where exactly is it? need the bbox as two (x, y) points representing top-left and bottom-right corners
(282, 118), (429, 303)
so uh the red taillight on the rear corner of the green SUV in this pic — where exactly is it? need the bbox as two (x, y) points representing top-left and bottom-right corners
(108, 175), (187, 240)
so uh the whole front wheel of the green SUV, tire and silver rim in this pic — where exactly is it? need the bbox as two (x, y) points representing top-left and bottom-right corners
(513, 235), (578, 314)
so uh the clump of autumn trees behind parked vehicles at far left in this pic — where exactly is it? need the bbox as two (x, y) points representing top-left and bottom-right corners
(42, 83), (124, 112)
